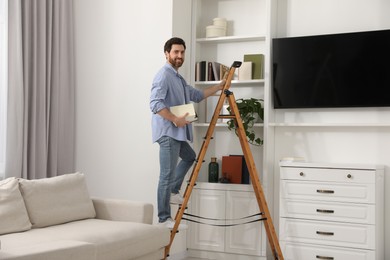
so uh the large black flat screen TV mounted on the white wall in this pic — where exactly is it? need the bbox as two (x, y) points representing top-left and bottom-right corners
(272, 30), (390, 108)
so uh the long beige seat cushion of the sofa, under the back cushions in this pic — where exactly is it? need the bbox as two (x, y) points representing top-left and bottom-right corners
(1, 219), (170, 260)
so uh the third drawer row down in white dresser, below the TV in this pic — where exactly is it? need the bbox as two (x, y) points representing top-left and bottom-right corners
(280, 198), (375, 225)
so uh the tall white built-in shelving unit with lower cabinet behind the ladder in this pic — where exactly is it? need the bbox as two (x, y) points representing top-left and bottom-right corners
(181, 0), (274, 259)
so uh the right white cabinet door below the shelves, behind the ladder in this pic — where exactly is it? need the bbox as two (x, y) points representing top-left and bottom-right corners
(225, 191), (263, 256)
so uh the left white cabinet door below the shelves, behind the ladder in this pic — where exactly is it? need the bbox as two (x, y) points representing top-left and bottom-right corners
(187, 189), (225, 252)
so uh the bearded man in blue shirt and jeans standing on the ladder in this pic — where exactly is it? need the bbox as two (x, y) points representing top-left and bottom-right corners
(150, 37), (225, 228)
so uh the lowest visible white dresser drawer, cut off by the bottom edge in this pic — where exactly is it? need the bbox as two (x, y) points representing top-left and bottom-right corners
(280, 242), (376, 260)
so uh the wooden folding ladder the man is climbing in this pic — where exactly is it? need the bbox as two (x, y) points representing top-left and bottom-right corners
(165, 61), (284, 260)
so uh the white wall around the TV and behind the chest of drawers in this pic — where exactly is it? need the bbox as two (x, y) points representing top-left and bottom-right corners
(274, 0), (390, 259)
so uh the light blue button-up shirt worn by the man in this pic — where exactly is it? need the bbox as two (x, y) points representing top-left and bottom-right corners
(150, 63), (204, 142)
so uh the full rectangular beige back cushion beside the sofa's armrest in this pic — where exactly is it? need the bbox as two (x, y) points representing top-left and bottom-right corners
(19, 172), (96, 228)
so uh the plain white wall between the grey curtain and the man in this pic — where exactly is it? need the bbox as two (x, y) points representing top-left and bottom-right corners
(74, 0), (172, 209)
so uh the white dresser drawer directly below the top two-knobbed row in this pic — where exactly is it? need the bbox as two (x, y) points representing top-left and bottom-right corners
(280, 180), (375, 204)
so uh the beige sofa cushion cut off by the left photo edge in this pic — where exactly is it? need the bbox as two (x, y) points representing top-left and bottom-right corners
(0, 178), (31, 235)
